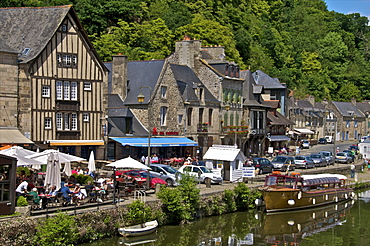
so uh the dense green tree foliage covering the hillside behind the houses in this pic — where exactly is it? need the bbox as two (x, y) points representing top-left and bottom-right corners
(5, 0), (370, 100)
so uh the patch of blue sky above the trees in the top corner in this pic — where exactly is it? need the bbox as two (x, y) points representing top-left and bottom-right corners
(324, 0), (370, 19)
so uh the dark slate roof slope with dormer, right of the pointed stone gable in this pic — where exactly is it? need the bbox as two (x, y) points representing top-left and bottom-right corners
(170, 64), (219, 103)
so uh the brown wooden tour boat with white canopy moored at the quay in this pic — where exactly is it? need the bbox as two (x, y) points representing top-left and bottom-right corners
(256, 173), (355, 212)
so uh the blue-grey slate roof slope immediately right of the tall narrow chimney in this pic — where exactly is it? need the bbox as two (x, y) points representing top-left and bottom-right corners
(124, 60), (165, 105)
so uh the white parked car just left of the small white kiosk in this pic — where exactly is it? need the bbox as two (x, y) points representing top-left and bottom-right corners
(179, 165), (222, 184)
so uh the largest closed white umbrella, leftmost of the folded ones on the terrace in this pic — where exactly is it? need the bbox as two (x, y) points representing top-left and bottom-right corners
(45, 152), (61, 190)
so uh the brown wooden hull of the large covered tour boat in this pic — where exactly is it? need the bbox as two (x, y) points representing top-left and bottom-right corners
(262, 188), (354, 212)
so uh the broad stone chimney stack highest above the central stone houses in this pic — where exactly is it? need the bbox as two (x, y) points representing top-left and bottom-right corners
(175, 35), (202, 68)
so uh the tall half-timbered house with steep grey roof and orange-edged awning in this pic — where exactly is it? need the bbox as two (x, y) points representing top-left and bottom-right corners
(0, 5), (108, 159)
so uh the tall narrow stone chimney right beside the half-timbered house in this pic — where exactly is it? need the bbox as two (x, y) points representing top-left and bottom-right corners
(111, 54), (127, 99)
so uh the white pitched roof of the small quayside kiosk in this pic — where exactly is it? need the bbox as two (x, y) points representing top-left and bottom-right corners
(203, 147), (247, 162)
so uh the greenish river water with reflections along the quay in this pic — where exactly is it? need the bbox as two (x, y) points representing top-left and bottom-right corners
(80, 190), (370, 246)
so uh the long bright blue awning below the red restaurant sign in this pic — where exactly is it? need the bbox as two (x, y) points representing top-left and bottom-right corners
(110, 137), (198, 147)
